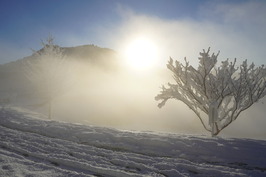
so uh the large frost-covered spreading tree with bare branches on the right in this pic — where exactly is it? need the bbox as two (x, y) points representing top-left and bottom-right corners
(155, 48), (266, 136)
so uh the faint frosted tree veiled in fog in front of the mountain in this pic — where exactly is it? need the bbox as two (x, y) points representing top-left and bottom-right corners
(26, 37), (69, 119)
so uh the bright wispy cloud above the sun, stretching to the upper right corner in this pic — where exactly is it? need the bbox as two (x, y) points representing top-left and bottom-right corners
(110, 1), (266, 64)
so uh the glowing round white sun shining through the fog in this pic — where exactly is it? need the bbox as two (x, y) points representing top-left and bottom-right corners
(125, 37), (158, 70)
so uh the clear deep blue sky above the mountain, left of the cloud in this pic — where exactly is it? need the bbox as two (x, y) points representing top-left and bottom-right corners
(0, 0), (202, 45)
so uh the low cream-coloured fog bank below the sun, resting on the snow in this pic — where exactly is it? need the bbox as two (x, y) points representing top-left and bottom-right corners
(29, 55), (265, 139)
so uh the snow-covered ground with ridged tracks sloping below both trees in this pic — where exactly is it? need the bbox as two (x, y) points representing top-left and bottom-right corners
(0, 108), (266, 177)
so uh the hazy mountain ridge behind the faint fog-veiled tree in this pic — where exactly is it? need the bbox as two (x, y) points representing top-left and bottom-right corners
(0, 45), (120, 101)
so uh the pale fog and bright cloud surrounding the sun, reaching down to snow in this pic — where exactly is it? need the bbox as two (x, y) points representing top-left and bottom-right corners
(2, 1), (266, 139)
